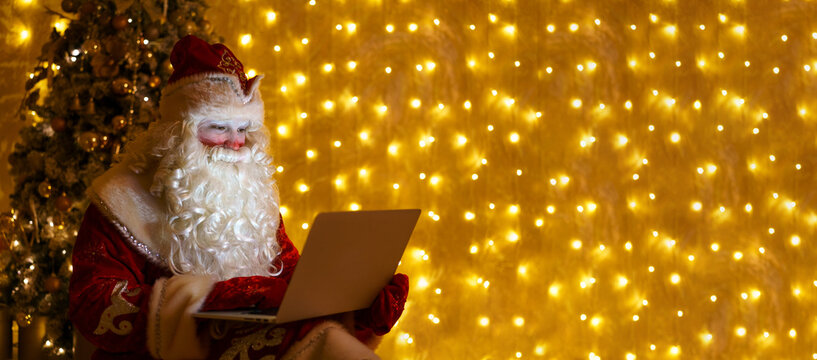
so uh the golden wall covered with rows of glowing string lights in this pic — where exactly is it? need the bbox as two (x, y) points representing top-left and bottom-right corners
(3, 0), (817, 359)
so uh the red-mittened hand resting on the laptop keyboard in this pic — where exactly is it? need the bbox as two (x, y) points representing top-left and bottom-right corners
(201, 276), (287, 311)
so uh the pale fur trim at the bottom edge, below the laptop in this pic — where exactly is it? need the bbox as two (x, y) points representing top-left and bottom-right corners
(283, 321), (380, 360)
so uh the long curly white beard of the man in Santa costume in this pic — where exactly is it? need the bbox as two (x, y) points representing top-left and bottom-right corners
(151, 138), (282, 280)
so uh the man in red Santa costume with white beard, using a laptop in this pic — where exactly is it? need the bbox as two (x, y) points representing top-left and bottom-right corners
(70, 36), (408, 359)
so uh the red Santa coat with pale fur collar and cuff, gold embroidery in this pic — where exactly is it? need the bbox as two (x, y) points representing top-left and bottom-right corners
(69, 165), (408, 359)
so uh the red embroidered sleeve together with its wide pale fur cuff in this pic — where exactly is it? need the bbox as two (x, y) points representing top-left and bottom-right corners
(69, 205), (214, 359)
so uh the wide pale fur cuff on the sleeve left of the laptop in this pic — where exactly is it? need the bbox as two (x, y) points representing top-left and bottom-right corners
(147, 275), (215, 359)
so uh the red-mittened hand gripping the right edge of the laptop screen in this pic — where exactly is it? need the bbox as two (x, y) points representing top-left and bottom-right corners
(355, 274), (408, 335)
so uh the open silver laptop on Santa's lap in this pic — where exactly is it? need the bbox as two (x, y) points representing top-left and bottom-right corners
(193, 209), (420, 324)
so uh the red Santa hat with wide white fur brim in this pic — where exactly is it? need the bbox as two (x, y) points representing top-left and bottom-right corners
(159, 35), (264, 131)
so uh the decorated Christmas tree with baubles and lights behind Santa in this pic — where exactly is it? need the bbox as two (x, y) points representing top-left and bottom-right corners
(0, 0), (217, 358)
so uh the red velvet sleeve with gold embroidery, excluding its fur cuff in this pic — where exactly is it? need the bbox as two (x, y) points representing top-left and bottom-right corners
(69, 205), (174, 353)
